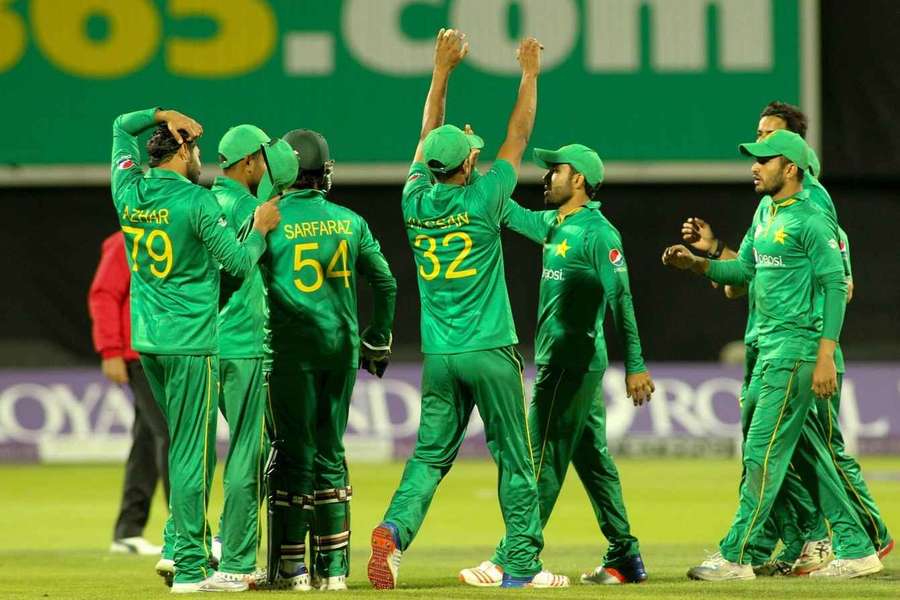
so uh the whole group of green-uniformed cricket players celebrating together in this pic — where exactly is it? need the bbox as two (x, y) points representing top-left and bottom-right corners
(112, 30), (893, 593)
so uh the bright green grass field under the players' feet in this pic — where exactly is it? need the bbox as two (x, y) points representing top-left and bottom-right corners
(0, 459), (900, 600)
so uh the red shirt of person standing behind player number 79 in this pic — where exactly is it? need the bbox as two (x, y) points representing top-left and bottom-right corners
(88, 231), (138, 360)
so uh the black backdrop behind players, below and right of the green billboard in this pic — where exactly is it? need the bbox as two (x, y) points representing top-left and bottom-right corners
(0, 0), (900, 366)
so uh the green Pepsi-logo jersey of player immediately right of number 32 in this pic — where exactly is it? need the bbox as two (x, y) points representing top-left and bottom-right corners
(503, 198), (647, 373)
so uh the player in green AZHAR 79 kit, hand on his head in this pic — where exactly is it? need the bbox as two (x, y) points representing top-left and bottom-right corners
(111, 108), (279, 593)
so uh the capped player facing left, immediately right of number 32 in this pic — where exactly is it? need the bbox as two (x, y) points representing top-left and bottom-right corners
(459, 144), (654, 587)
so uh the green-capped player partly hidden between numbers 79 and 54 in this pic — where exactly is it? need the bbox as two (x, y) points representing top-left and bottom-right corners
(206, 125), (271, 581)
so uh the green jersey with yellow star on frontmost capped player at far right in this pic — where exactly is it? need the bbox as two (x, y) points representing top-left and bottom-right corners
(707, 190), (847, 361)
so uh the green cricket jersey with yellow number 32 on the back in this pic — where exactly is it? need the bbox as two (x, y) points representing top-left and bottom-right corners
(402, 160), (518, 354)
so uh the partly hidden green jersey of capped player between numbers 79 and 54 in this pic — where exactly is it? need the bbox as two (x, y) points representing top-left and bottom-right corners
(212, 177), (269, 358)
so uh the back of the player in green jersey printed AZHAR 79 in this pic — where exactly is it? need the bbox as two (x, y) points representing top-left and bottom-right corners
(113, 168), (225, 354)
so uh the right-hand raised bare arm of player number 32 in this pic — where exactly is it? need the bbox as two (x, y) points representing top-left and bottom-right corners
(497, 38), (542, 173)
